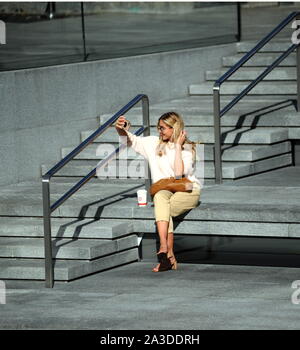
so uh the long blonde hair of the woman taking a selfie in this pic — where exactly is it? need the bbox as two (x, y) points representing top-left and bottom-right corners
(156, 112), (196, 158)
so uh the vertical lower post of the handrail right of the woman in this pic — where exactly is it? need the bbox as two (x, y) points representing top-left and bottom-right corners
(213, 85), (222, 184)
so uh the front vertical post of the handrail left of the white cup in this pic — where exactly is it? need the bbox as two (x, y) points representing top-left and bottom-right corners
(42, 177), (54, 288)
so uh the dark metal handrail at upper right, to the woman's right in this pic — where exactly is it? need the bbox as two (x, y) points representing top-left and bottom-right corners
(213, 12), (300, 184)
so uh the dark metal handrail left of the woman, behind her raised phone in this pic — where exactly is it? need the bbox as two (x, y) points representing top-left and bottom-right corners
(42, 94), (151, 288)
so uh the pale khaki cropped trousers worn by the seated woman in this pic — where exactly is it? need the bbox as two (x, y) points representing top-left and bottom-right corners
(153, 188), (201, 233)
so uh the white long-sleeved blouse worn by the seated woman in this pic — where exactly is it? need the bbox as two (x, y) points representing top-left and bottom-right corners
(126, 131), (202, 188)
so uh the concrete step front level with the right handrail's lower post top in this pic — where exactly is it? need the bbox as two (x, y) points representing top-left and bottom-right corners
(189, 81), (297, 96)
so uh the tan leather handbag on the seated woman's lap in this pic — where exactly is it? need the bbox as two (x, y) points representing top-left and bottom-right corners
(150, 177), (193, 196)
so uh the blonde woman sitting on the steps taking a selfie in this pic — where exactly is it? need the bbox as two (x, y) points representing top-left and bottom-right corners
(115, 112), (201, 272)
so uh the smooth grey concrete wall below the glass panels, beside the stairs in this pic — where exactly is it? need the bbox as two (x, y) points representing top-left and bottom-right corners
(0, 44), (236, 185)
